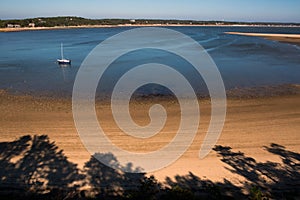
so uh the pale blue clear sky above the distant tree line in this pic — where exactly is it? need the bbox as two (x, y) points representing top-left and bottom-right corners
(0, 0), (300, 23)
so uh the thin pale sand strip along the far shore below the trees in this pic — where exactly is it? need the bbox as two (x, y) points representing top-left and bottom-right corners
(0, 24), (299, 32)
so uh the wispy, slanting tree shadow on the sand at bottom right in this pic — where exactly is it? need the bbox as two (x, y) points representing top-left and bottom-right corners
(214, 143), (300, 199)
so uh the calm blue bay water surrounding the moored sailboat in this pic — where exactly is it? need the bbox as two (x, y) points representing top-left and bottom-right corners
(0, 27), (300, 96)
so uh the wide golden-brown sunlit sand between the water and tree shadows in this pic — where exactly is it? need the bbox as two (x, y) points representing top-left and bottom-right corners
(0, 85), (300, 185)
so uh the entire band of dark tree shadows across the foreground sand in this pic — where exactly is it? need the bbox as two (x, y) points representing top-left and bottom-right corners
(0, 135), (300, 199)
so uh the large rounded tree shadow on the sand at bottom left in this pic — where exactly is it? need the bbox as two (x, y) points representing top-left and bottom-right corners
(0, 135), (85, 198)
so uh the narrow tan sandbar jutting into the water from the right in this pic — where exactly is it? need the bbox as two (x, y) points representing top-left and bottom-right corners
(226, 32), (300, 45)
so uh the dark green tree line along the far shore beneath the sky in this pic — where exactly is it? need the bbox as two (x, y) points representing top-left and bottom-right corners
(0, 16), (300, 28)
